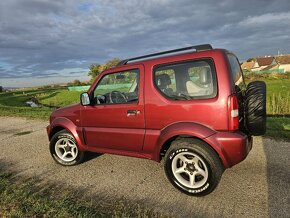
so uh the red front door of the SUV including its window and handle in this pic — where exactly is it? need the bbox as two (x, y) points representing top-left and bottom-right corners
(81, 65), (145, 151)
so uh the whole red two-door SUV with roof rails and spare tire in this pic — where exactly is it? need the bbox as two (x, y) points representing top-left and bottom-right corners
(47, 44), (266, 196)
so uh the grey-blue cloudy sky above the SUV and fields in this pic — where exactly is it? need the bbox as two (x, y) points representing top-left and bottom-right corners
(0, 0), (290, 87)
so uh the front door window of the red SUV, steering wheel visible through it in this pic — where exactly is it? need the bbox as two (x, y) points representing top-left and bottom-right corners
(93, 69), (139, 104)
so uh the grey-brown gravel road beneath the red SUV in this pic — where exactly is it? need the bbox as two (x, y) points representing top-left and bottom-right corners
(0, 117), (290, 217)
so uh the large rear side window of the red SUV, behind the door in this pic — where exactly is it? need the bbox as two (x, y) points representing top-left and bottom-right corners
(154, 60), (217, 100)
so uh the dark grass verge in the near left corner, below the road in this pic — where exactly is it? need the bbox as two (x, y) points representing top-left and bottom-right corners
(0, 170), (165, 217)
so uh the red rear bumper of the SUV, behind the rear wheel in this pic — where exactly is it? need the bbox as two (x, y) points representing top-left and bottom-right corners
(206, 132), (253, 168)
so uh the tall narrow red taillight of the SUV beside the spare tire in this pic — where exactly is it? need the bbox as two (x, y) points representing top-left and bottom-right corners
(228, 95), (239, 131)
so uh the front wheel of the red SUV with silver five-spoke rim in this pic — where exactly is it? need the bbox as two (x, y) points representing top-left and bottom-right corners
(50, 130), (84, 166)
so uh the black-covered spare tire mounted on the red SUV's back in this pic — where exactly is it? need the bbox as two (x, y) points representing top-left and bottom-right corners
(245, 81), (266, 136)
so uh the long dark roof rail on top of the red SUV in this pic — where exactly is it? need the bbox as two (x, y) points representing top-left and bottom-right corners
(117, 44), (212, 66)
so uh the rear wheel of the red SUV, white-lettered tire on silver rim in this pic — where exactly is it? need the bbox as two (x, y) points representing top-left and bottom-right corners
(164, 138), (224, 197)
